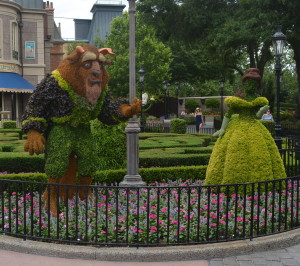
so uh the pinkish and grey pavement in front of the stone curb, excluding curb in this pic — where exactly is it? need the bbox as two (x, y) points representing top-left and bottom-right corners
(0, 244), (300, 266)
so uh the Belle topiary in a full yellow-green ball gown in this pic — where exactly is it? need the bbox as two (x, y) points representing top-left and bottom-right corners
(205, 68), (286, 185)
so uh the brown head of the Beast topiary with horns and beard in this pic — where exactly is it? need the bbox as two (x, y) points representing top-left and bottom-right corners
(57, 45), (114, 104)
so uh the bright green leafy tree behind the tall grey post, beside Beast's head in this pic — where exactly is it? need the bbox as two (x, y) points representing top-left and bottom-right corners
(105, 12), (172, 97)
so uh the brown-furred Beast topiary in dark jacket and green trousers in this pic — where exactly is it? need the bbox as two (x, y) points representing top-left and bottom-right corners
(22, 45), (141, 215)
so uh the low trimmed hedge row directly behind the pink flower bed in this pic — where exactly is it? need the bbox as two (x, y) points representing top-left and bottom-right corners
(0, 165), (207, 184)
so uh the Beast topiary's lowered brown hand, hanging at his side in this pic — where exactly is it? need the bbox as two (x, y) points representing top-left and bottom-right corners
(24, 130), (45, 155)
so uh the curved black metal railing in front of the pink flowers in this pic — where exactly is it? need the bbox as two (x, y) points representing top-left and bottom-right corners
(0, 149), (300, 246)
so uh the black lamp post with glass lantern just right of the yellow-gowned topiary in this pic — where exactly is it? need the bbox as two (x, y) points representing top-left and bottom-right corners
(272, 26), (286, 149)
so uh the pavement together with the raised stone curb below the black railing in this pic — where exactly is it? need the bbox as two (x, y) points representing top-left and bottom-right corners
(0, 229), (300, 266)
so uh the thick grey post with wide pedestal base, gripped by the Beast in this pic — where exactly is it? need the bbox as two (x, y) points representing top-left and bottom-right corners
(120, 0), (145, 186)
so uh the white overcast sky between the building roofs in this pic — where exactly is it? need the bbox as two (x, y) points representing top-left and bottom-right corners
(50, 0), (128, 39)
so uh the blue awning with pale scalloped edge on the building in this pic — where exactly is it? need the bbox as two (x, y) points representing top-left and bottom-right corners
(0, 72), (35, 93)
